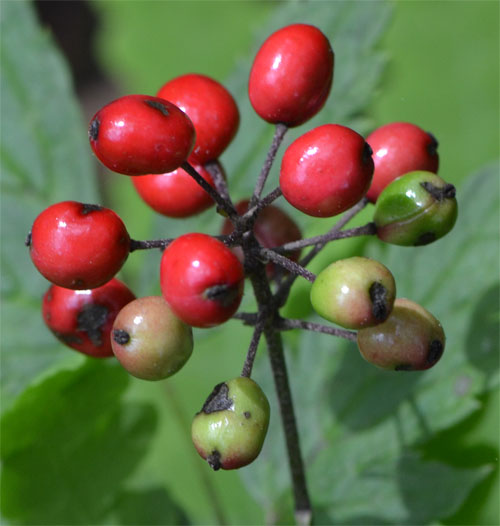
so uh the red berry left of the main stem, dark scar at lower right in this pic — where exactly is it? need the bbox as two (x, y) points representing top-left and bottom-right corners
(160, 233), (245, 328)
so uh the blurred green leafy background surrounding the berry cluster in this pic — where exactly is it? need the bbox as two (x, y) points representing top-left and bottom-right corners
(0, 0), (499, 524)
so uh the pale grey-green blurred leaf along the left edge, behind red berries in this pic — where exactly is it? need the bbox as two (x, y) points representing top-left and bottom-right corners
(0, 2), (97, 409)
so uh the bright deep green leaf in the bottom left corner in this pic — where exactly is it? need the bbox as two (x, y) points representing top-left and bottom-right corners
(1, 360), (157, 524)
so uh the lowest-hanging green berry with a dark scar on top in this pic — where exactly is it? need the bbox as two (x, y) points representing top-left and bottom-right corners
(191, 377), (270, 470)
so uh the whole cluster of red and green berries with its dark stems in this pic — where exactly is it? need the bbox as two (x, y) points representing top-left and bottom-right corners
(27, 24), (457, 507)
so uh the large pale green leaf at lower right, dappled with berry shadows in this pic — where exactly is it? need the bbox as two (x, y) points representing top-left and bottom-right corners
(243, 164), (500, 524)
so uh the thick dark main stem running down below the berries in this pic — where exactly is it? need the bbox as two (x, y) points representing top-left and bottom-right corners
(250, 264), (312, 525)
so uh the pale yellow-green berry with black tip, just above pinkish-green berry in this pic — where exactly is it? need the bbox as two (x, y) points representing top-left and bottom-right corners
(311, 256), (396, 329)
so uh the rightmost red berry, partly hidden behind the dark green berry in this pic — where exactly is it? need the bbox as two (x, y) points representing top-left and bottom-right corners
(366, 122), (439, 203)
